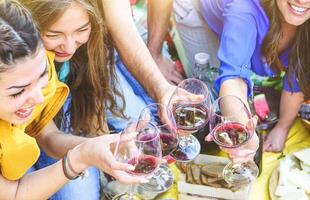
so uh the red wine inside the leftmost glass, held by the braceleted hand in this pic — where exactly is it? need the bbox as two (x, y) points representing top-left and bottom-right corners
(128, 155), (159, 175)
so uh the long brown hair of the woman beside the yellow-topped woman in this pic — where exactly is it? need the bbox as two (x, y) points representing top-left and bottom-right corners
(21, 0), (123, 136)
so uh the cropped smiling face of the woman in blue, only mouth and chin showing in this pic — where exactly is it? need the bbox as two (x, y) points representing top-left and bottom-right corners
(276, 0), (310, 26)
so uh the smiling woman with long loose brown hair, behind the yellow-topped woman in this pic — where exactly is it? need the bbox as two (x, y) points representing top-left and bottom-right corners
(21, 0), (139, 199)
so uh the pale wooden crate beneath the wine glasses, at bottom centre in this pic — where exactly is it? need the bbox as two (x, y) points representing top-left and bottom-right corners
(178, 154), (251, 200)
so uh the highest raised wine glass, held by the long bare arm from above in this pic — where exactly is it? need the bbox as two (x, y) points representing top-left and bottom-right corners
(168, 78), (211, 162)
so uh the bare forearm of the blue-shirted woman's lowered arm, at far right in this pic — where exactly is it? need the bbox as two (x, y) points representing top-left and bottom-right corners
(277, 90), (304, 129)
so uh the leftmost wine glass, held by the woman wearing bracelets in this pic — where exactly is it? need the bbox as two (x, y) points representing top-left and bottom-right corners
(113, 120), (162, 200)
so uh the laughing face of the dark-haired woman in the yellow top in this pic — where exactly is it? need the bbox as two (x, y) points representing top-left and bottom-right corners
(0, 48), (48, 125)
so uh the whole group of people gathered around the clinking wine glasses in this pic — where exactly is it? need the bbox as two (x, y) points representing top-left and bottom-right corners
(0, 0), (310, 199)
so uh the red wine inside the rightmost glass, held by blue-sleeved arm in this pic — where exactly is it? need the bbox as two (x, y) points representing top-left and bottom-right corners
(213, 122), (251, 148)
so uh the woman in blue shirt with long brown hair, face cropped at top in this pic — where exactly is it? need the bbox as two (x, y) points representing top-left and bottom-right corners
(201, 0), (310, 152)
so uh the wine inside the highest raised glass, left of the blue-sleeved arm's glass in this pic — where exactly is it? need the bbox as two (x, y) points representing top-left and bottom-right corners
(173, 104), (208, 131)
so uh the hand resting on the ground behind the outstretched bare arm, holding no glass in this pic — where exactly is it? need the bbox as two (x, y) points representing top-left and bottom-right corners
(153, 54), (184, 85)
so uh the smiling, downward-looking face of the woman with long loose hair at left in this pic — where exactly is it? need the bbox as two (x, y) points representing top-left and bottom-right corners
(42, 1), (91, 62)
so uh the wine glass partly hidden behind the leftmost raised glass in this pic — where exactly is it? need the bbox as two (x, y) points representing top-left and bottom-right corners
(139, 103), (178, 193)
